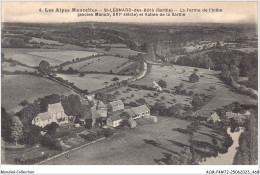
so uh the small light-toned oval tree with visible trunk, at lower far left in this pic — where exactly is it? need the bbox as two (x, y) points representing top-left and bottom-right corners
(11, 116), (23, 146)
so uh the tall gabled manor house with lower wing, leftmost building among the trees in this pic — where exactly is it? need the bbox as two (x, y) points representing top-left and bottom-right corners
(32, 103), (69, 127)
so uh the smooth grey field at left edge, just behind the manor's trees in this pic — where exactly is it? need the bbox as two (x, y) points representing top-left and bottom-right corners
(1, 75), (73, 112)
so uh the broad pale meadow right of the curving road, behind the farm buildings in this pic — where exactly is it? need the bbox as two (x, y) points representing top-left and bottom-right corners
(116, 65), (257, 116)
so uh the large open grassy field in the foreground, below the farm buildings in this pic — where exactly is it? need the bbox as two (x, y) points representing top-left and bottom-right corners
(40, 117), (219, 165)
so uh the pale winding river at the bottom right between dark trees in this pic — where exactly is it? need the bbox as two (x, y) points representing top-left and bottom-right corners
(199, 128), (244, 165)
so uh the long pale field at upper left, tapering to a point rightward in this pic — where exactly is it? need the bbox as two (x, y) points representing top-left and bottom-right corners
(2, 48), (97, 66)
